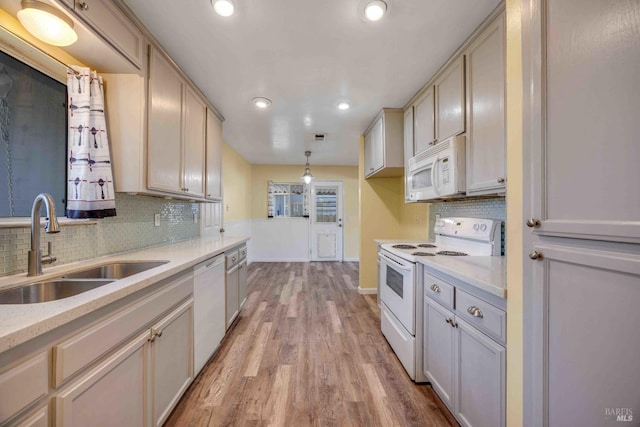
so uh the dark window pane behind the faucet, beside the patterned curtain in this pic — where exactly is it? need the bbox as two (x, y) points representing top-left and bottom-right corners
(0, 52), (67, 217)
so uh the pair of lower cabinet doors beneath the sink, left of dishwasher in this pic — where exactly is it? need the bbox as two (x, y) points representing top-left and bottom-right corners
(54, 300), (193, 426)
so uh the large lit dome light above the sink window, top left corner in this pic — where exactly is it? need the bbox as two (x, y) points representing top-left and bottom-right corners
(18, 0), (78, 46)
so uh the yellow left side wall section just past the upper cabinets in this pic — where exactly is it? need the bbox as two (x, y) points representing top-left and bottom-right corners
(222, 143), (252, 222)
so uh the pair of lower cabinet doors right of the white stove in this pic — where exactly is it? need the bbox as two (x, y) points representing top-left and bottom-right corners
(423, 280), (506, 427)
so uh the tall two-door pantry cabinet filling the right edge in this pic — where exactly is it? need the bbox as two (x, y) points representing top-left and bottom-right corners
(522, 0), (640, 426)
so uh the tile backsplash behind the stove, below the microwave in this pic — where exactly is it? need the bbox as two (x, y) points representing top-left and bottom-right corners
(429, 197), (507, 254)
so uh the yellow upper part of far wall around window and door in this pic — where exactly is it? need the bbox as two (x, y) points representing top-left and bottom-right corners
(251, 164), (360, 259)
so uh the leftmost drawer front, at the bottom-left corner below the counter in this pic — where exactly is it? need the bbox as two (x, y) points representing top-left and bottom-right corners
(0, 353), (49, 424)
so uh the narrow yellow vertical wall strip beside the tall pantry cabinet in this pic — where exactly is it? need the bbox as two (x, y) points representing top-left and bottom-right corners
(506, 0), (524, 427)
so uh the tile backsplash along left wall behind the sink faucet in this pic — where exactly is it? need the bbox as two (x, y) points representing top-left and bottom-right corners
(0, 194), (200, 276)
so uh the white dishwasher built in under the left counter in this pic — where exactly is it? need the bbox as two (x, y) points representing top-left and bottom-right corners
(193, 254), (226, 374)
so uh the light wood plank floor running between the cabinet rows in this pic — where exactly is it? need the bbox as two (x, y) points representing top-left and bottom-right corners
(166, 262), (457, 427)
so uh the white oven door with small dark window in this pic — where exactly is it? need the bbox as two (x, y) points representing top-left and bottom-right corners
(378, 251), (416, 335)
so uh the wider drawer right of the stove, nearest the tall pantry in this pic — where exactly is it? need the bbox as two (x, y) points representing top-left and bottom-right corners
(456, 289), (507, 344)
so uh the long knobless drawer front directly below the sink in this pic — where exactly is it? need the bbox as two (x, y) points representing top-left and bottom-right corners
(53, 275), (193, 387)
